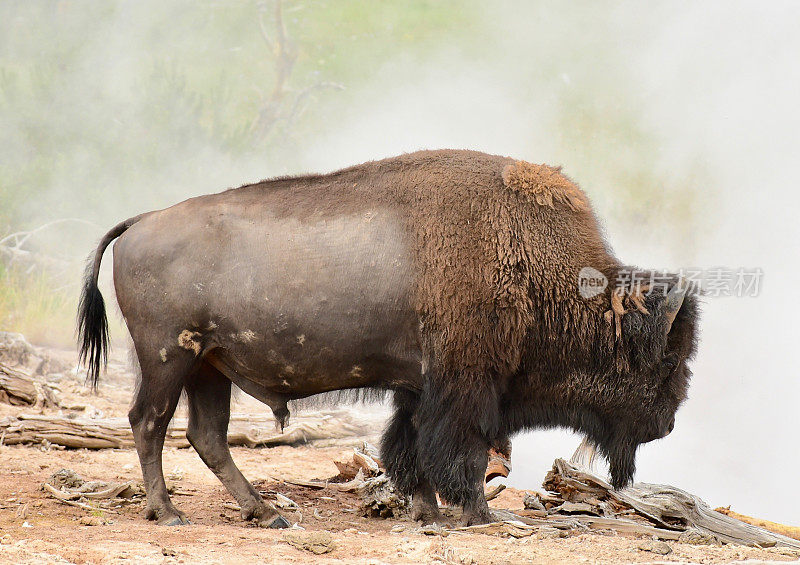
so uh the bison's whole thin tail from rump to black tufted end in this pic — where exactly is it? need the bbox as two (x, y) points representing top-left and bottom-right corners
(78, 214), (144, 388)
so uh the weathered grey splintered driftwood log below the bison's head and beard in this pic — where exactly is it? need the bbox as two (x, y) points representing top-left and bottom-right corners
(540, 459), (800, 548)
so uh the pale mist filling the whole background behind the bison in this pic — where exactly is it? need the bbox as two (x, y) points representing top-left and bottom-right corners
(0, 0), (800, 523)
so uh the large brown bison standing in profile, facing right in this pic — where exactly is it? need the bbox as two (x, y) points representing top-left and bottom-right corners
(78, 150), (698, 527)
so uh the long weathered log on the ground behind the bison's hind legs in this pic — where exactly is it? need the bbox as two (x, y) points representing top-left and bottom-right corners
(0, 411), (374, 449)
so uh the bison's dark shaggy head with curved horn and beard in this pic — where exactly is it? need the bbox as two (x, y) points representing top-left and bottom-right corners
(589, 281), (697, 488)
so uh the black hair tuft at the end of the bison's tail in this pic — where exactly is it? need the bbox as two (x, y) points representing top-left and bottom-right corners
(78, 261), (108, 389)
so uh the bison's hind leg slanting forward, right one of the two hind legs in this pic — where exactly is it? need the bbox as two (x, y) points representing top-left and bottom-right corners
(186, 363), (290, 528)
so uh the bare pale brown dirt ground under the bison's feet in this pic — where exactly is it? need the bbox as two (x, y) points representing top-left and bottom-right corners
(0, 346), (799, 564)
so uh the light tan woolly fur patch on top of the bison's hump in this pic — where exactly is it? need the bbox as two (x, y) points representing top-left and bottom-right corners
(503, 161), (589, 211)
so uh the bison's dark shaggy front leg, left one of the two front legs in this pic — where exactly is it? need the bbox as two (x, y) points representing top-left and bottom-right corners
(381, 391), (446, 524)
